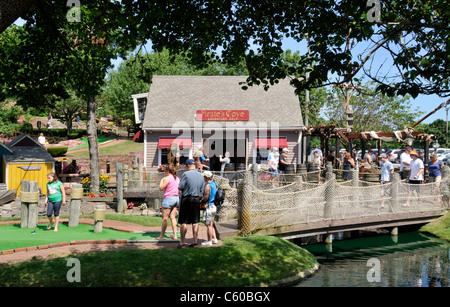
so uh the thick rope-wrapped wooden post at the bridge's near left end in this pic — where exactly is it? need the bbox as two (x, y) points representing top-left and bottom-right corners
(237, 172), (252, 237)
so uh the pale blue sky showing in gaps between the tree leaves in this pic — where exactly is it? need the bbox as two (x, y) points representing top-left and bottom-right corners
(15, 18), (448, 124)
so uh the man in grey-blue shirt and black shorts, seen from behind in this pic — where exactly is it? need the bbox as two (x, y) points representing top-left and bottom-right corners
(178, 159), (204, 248)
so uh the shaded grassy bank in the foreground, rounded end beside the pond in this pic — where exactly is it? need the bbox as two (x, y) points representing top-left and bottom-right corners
(0, 236), (315, 287)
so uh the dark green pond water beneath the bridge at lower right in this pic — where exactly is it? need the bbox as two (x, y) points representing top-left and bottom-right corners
(296, 232), (450, 287)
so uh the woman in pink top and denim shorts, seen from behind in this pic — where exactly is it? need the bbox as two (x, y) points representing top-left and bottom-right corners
(156, 164), (180, 240)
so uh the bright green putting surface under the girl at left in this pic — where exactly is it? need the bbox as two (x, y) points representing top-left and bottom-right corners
(0, 223), (176, 251)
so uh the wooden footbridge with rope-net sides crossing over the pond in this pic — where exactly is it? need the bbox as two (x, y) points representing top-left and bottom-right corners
(216, 166), (450, 239)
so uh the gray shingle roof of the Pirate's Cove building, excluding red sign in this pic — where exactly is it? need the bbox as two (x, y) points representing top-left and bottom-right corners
(143, 76), (303, 129)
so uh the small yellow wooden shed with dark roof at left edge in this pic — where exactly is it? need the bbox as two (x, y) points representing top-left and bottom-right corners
(3, 134), (55, 195)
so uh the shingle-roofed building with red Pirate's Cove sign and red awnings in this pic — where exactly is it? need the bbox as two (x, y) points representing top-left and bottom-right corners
(139, 76), (304, 170)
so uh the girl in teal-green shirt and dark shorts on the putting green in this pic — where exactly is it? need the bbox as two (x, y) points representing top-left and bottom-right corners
(45, 173), (66, 232)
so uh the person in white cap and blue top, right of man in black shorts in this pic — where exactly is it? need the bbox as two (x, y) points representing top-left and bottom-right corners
(200, 171), (218, 246)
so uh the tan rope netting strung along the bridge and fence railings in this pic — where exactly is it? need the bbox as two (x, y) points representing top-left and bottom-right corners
(118, 169), (450, 234)
